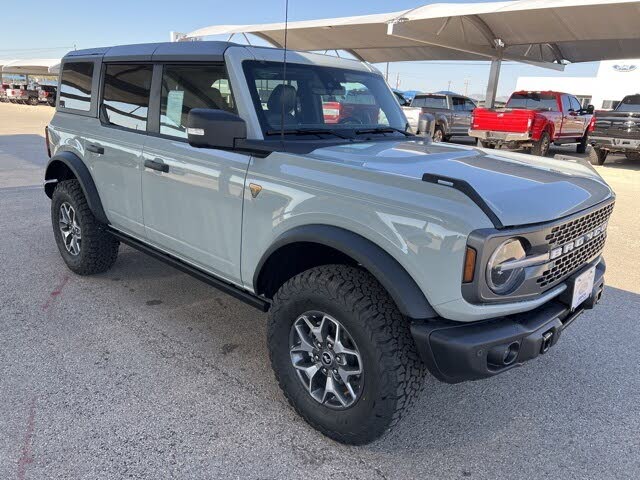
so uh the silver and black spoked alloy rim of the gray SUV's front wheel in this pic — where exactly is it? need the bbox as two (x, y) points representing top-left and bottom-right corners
(289, 311), (364, 410)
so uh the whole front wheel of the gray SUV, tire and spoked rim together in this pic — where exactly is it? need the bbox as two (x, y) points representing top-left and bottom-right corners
(268, 265), (424, 444)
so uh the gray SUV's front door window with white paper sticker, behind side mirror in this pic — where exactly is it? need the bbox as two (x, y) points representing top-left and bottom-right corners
(160, 65), (236, 138)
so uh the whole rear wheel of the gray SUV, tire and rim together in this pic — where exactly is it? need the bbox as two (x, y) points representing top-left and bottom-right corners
(51, 180), (120, 275)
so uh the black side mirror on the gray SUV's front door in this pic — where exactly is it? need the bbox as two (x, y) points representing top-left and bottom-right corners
(187, 108), (247, 149)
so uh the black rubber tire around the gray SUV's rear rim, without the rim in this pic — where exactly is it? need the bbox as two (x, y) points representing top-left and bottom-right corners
(51, 180), (120, 275)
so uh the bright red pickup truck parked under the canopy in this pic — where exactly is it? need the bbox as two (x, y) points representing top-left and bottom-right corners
(469, 91), (593, 156)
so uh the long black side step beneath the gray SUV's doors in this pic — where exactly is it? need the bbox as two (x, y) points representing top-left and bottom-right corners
(107, 227), (271, 312)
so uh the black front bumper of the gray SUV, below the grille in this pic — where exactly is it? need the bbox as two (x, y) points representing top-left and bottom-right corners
(411, 261), (605, 383)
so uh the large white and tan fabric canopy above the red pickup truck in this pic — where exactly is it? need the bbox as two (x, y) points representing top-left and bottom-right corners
(185, 0), (640, 69)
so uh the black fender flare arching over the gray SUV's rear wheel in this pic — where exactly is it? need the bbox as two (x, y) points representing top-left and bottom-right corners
(44, 152), (109, 224)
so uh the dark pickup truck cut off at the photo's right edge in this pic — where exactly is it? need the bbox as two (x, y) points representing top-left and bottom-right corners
(589, 94), (640, 165)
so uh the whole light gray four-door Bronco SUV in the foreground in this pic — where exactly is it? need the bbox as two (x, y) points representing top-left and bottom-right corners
(44, 42), (614, 444)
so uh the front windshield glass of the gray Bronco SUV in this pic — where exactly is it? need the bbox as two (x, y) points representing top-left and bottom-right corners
(243, 61), (407, 135)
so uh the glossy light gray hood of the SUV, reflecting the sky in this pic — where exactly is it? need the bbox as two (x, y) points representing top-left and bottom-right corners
(308, 141), (613, 227)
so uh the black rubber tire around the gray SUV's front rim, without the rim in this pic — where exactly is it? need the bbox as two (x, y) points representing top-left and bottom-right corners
(268, 265), (424, 445)
